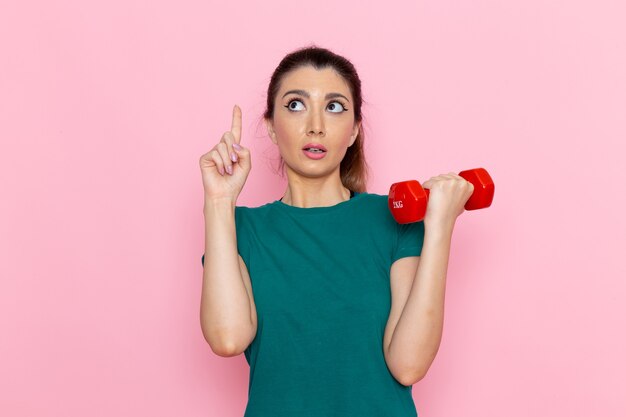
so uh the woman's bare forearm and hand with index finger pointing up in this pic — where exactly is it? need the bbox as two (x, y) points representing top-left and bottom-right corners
(200, 106), (252, 356)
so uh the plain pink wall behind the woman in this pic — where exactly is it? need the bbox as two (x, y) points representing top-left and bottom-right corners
(0, 0), (626, 417)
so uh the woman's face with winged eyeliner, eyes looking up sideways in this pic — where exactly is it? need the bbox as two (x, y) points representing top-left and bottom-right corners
(266, 66), (360, 177)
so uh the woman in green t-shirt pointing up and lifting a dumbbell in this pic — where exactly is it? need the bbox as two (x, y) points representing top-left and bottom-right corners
(200, 47), (473, 417)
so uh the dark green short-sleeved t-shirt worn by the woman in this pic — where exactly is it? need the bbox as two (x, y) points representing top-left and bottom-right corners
(202, 193), (424, 417)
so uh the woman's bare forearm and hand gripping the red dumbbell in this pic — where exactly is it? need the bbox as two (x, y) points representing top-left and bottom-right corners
(385, 173), (474, 386)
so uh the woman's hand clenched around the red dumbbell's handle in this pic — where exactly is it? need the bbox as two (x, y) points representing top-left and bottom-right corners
(422, 172), (474, 231)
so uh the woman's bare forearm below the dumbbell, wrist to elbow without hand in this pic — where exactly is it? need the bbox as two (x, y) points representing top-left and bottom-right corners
(389, 223), (454, 385)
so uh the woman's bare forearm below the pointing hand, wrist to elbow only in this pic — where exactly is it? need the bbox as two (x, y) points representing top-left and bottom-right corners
(200, 199), (257, 356)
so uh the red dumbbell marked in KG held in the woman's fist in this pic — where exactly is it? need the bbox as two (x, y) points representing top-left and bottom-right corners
(389, 168), (495, 224)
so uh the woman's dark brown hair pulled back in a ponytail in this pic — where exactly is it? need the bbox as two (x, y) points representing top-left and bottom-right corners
(263, 45), (368, 192)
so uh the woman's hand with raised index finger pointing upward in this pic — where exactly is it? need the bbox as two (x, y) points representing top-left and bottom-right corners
(200, 105), (252, 202)
